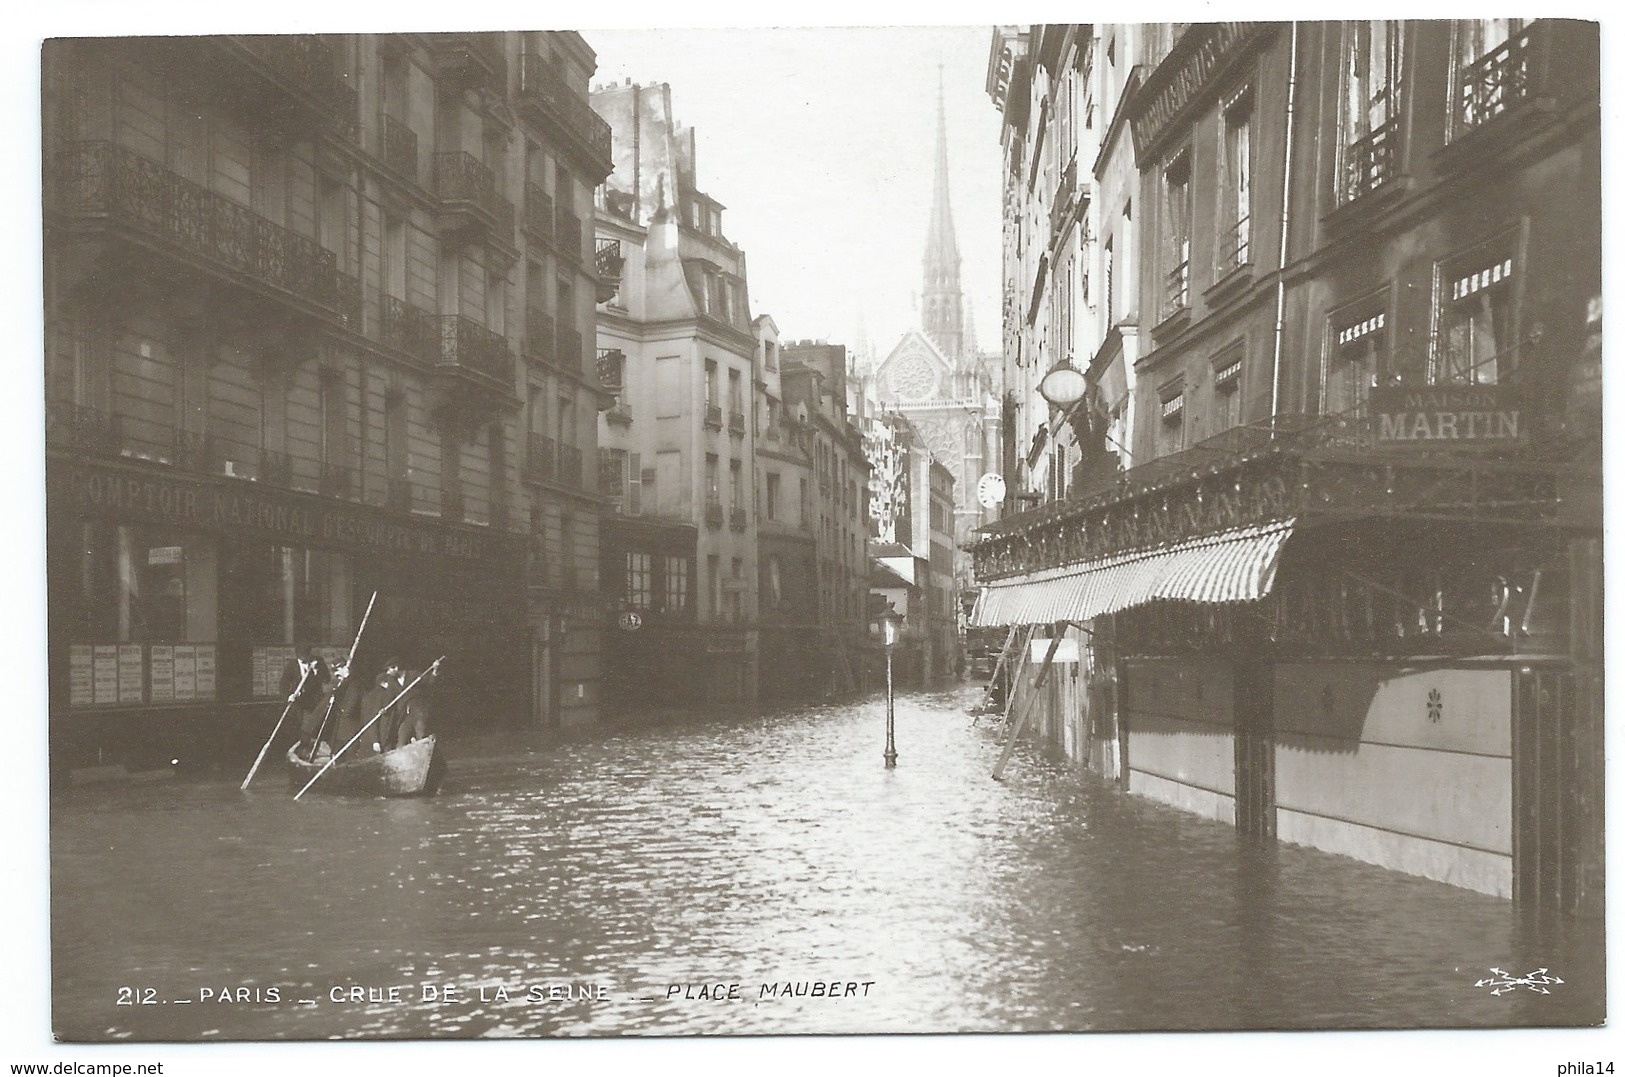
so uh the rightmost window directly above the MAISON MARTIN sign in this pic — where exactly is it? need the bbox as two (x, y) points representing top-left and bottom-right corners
(1428, 244), (1518, 385)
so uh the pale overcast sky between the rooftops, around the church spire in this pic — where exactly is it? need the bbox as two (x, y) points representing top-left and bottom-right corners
(582, 24), (999, 356)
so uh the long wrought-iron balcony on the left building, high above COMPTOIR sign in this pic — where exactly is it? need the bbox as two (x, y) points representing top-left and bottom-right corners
(47, 141), (361, 328)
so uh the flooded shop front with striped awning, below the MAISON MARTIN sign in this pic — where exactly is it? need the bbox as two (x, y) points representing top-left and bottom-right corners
(973, 445), (1601, 910)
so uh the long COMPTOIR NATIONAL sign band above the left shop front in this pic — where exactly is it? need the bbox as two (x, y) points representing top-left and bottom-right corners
(57, 463), (512, 560)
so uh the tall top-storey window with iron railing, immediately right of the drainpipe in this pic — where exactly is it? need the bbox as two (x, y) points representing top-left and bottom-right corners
(1337, 21), (1402, 201)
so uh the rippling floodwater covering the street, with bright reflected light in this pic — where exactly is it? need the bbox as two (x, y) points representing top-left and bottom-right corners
(50, 689), (1604, 1041)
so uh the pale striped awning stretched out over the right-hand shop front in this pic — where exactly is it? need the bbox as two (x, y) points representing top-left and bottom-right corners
(970, 520), (1294, 627)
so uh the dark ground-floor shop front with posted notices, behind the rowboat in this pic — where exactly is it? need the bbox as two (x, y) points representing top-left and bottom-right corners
(46, 460), (528, 770)
